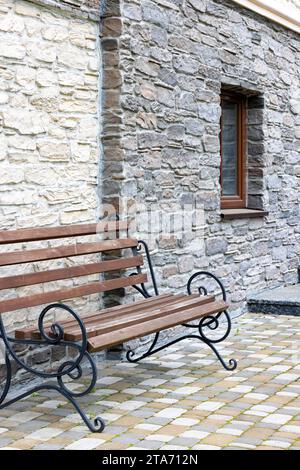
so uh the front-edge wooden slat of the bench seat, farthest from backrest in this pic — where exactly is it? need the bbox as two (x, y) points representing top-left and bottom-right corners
(88, 301), (228, 352)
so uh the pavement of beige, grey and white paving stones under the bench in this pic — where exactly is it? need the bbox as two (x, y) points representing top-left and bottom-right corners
(0, 314), (300, 450)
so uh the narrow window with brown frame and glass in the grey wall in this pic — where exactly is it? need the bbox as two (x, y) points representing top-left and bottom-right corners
(220, 92), (247, 209)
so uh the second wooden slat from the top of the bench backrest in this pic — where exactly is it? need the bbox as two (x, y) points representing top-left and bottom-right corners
(0, 238), (138, 266)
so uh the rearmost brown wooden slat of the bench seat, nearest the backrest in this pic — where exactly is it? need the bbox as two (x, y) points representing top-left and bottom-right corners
(15, 294), (179, 339)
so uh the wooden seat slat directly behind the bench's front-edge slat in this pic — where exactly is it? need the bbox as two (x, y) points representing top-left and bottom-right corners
(65, 296), (215, 341)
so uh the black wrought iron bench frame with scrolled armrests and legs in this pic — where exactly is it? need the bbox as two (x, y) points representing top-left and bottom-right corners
(0, 224), (237, 432)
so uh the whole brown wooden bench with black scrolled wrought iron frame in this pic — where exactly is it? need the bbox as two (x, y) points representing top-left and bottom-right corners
(0, 222), (237, 432)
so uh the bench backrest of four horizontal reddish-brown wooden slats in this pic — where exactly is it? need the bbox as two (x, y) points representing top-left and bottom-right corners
(0, 221), (147, 315)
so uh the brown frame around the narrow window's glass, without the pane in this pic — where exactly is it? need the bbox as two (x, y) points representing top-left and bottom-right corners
(220, 92), (247, 209)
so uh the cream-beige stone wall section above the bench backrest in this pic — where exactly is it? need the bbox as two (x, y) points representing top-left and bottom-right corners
(0, 0), (100, 229)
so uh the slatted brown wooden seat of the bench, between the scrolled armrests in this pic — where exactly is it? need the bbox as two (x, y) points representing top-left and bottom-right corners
(15, 294), (228, 352)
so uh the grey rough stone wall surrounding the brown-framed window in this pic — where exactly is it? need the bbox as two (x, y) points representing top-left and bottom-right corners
(102, 0), (300, 311)
